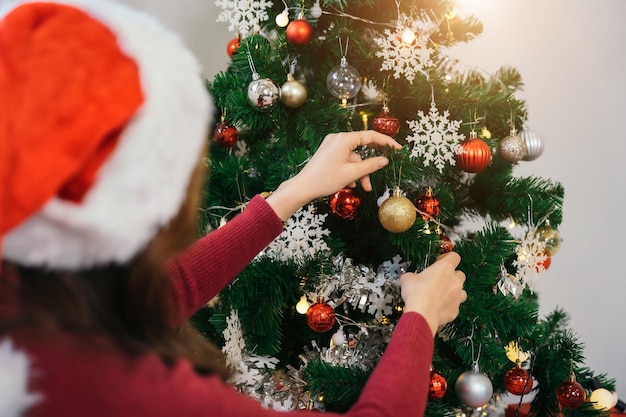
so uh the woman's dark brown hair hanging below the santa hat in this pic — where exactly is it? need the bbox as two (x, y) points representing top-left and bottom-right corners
(0, 155), (229, 378)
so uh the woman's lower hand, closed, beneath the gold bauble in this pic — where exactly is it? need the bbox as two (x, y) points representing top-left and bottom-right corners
(400, 252), (467, 336)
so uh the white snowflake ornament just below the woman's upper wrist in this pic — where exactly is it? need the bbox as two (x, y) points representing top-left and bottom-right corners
(264, 204), (330, 262)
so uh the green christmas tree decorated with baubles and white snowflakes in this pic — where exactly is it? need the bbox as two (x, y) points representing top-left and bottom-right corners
(193, 0), (617, 416)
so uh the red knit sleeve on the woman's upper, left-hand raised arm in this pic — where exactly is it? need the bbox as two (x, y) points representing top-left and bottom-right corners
(166, 196), (282, 317)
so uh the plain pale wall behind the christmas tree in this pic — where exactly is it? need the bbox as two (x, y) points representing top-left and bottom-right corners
(126, 0), (626, 400)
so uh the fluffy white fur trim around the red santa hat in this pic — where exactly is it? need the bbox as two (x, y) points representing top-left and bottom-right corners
(0, 0), (211, 269)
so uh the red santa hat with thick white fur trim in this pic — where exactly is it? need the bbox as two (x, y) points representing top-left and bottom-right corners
(0, 0), (211, 269)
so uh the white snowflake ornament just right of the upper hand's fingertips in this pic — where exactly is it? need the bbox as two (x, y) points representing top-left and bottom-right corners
(406, 102), (465, 173)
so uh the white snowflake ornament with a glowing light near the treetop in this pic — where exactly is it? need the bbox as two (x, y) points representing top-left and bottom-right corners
(374, 16), (434, 83)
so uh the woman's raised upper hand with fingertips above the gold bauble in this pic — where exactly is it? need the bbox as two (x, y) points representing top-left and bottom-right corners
(267, 130), (402, 220)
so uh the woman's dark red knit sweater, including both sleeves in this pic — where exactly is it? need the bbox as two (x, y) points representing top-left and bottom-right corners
(20, 197), (433, 417)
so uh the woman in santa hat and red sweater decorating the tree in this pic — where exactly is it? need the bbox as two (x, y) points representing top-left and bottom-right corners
(0, 0), (466, 417)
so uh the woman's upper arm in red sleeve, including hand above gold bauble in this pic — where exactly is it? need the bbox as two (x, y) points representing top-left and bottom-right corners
(167, 131), (401, 317)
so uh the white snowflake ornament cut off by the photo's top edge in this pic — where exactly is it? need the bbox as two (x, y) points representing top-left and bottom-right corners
(215, 0), (273, 35)
